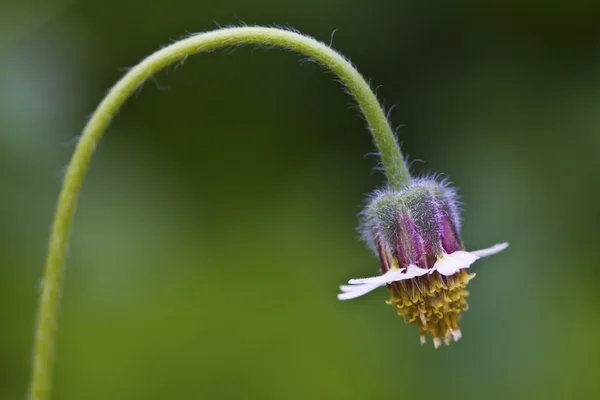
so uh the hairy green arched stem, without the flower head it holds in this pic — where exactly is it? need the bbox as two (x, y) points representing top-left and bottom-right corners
(29, 27), (410, 400)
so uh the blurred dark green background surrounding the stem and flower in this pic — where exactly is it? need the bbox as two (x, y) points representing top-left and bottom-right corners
(0, 0), (600, 400)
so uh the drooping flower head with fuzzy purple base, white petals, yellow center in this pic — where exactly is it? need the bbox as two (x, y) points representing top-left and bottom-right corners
(338, 179), (508, 348)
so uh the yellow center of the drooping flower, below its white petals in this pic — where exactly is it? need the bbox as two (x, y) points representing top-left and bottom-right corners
(387, 269), (475, 348)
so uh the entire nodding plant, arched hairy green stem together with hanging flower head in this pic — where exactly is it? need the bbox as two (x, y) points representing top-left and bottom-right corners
(28, 26), (507, 400)
